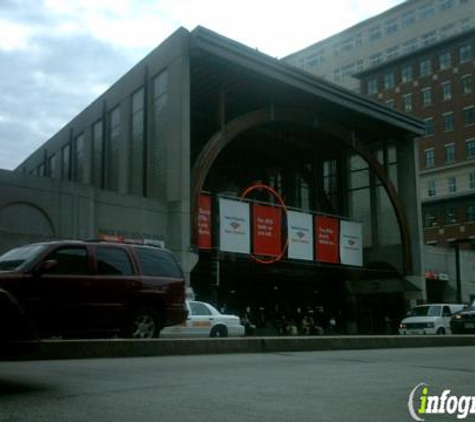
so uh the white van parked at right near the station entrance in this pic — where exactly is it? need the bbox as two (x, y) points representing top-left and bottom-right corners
(399, 303), (465, 335)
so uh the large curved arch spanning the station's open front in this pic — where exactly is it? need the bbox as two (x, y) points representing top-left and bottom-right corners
(190, 107), (412, 273)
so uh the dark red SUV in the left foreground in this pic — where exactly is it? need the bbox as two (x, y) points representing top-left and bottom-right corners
(0, 241), (186, 341)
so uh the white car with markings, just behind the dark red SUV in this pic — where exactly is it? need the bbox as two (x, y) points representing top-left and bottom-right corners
(160, 300), (245, 338)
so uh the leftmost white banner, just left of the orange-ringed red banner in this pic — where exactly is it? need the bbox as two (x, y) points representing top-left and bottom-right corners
(219, 198), (251, 254)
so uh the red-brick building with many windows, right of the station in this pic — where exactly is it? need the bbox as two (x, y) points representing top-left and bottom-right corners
(359, 30), (475, 246)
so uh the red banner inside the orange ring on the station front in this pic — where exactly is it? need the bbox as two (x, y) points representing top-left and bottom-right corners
(252, 204), (282, 257)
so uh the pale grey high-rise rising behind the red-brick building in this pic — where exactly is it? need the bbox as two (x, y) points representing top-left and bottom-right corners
(283, 0), (475, 92)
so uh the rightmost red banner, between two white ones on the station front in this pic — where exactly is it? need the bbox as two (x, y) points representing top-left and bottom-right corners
(315, 215), (340, 264)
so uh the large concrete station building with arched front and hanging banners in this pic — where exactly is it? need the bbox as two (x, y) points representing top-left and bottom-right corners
(0, 28), (426, 333)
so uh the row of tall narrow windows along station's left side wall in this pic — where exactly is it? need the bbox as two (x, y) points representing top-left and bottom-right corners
(29, 71), (168, 195)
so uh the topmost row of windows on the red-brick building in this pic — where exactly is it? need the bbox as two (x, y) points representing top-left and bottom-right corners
(367, 42), (473, 95)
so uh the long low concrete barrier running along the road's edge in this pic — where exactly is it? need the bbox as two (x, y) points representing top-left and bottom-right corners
(3, 335), (475, 360)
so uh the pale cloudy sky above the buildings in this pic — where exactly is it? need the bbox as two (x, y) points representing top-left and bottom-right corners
(0, 0), (404, 170)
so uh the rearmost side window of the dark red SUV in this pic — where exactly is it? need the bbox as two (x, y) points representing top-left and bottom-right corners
(135, 247), (182, 278)
